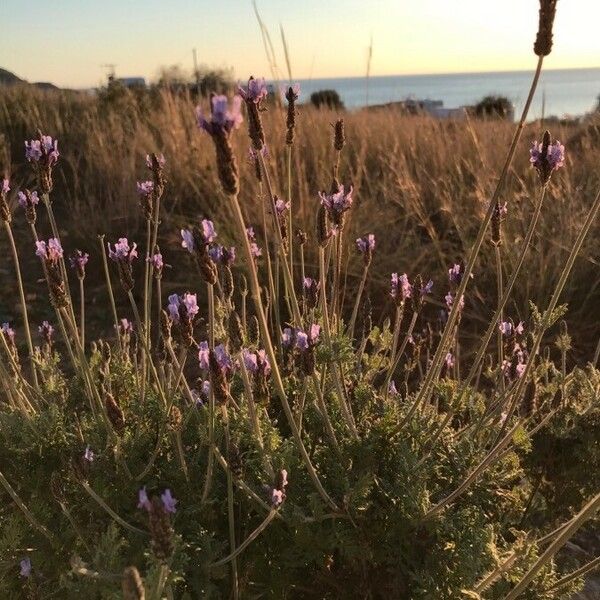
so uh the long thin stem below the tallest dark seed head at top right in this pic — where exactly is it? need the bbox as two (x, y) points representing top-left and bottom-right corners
(415, 56), (544, 408)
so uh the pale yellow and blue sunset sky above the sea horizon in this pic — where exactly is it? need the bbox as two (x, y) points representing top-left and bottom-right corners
(0, 0), (600, 88)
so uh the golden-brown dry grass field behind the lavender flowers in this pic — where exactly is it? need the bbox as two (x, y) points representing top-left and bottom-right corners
(0, 88), (600, 358)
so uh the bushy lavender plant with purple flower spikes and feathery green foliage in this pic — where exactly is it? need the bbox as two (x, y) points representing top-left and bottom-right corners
(0, 0), (600, 600)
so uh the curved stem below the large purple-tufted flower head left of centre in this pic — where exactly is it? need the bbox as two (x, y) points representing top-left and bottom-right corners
(230, 191), (337, 510)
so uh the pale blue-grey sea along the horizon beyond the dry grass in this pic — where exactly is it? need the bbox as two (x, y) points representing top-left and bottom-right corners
(300, 68), (600, 119)
